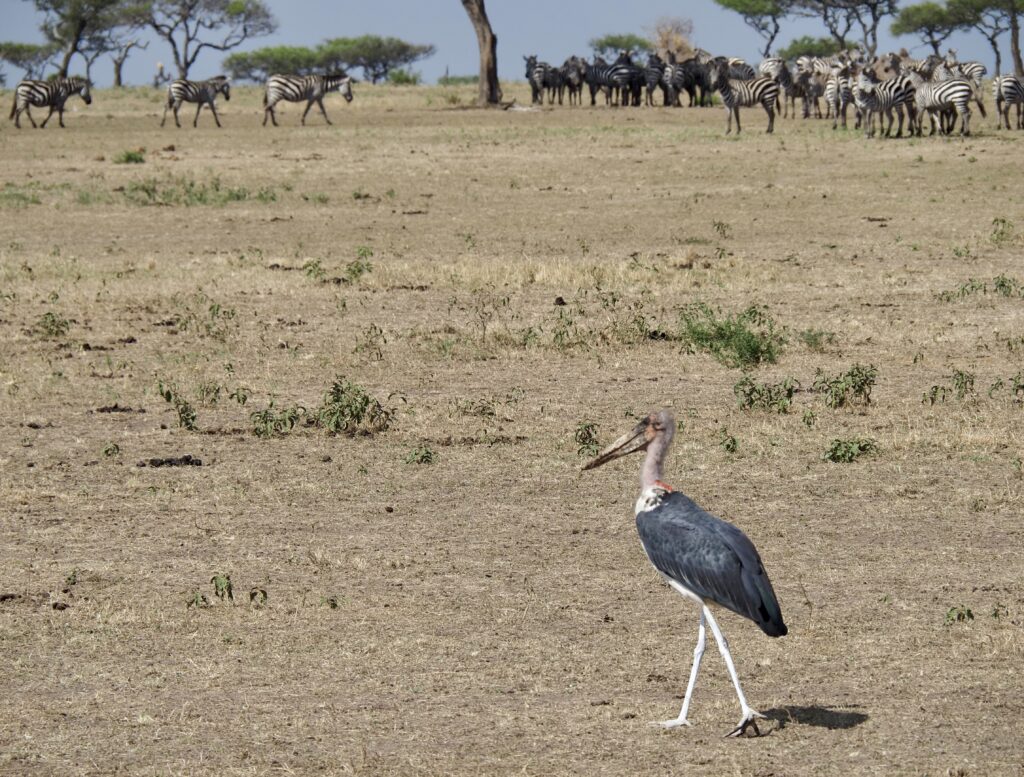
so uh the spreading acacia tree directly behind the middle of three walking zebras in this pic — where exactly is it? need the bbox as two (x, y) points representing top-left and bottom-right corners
(135, 0), (278, 78)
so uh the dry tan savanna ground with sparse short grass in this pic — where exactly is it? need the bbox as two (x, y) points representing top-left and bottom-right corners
(0, 85), (1024, 775)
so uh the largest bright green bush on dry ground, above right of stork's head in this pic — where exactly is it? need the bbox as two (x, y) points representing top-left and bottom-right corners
(679, 303), (785, 370)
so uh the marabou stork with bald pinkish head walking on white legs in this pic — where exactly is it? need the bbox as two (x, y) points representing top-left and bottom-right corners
(584, 409), (787, 736)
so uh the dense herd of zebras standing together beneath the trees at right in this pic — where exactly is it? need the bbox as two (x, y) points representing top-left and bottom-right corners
(523, 49), (1024, 137)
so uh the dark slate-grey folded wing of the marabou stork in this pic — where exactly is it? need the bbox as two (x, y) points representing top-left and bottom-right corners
(637, 492), (786, 637)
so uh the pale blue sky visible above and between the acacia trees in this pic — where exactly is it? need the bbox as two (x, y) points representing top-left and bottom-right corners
(0, 0), (1009, 86)
